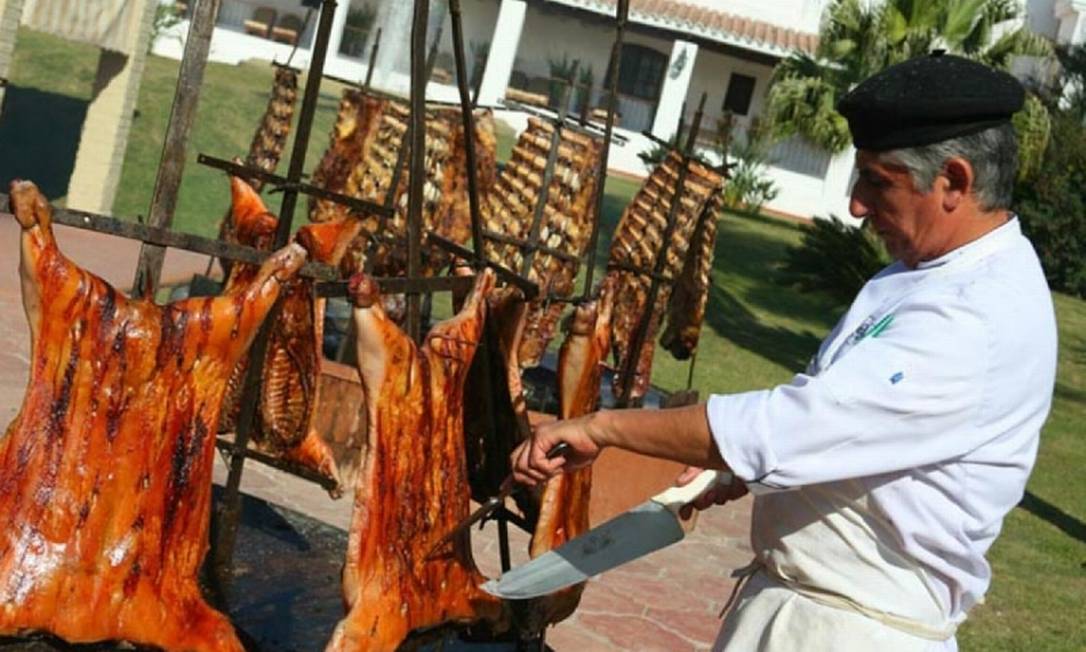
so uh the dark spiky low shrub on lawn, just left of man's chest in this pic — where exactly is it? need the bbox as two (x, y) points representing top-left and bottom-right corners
(781, 215), (891, 302)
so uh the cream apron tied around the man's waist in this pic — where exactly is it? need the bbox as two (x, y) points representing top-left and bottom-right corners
(714, 269), (964, 652)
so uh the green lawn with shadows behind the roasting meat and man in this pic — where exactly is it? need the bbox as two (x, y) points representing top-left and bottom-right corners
(0, 24), (1086, 651)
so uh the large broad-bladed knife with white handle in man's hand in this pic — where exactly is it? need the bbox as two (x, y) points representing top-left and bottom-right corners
(482, 471), (732, 600)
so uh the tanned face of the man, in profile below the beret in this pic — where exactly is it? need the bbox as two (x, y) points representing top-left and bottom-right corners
(848, 150), (942, 267)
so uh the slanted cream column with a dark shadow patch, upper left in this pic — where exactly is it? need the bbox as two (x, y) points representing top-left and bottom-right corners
(67, 2), (155, 213)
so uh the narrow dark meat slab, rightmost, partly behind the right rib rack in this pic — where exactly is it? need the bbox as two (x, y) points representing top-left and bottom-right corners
(660, 195), (723, 360)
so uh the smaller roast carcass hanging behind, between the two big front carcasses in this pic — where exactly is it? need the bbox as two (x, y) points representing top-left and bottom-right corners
(223, 177), (362, 497)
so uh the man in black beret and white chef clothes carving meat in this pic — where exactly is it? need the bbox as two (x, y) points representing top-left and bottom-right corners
(514, 54), (1056, 652)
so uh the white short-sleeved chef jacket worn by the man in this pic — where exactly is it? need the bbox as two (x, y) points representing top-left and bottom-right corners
(708, 218), (1057, 649)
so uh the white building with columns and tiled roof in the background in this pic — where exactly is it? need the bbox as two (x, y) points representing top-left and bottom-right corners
(155, 0), (1086, 216)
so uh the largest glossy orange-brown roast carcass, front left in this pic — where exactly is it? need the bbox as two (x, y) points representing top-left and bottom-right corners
(0, 181), (305, 652)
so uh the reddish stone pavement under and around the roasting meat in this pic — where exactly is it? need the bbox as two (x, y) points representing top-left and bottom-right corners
(0, 213), (750, 652)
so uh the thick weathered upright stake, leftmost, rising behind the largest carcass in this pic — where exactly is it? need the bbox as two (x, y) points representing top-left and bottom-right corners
(132, 0), (222, 298)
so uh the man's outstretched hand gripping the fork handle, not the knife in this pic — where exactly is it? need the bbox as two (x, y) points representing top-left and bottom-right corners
(509, 412), (603, 487)
